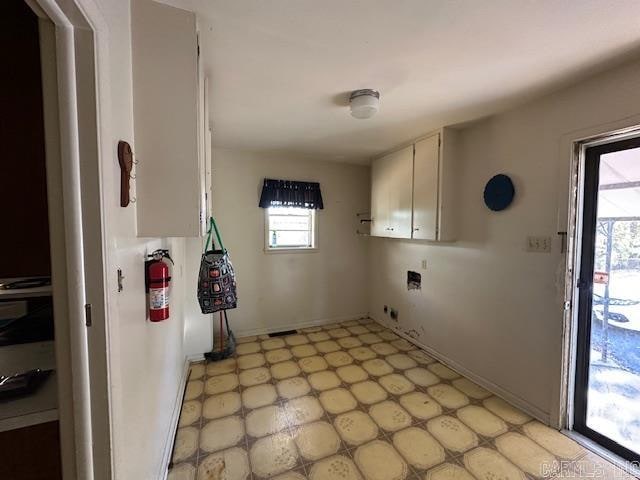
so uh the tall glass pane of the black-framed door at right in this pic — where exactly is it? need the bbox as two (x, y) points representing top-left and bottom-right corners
(586, 148), (640, 453)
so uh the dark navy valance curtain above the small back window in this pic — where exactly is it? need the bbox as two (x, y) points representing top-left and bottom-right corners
(259, 178), (324, 210)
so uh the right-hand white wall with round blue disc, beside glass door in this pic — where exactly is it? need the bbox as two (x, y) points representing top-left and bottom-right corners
(369, 62), (640, 419)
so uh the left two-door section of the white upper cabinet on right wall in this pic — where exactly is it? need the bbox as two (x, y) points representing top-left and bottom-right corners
(371, 145), (413, 238)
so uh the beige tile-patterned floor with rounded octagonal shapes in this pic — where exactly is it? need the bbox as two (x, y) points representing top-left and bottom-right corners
(169, 319), (632, 480)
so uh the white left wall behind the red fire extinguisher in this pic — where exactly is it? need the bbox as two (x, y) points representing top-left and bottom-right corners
(96, 0), (190, 479)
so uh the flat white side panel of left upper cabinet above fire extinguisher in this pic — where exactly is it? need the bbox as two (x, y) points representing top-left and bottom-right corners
(131, 0), (203, 237)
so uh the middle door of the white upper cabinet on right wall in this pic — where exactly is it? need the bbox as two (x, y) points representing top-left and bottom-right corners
(387, 145), (413, 238)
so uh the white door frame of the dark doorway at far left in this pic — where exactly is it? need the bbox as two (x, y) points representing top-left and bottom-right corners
(26, 0), (113, 480)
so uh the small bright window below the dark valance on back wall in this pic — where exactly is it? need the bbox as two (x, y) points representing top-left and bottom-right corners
(265, 207), (317, 251)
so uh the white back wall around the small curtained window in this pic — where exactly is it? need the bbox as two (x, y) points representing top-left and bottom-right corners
(182, 149), (370, 354)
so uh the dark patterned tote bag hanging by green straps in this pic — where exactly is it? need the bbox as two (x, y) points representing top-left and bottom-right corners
(198, 217), (238, 313)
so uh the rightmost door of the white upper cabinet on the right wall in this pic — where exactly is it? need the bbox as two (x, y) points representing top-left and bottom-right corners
(412, 134), (440, 240)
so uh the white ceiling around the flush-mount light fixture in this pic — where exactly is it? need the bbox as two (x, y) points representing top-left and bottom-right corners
(163, 0), (640, 163)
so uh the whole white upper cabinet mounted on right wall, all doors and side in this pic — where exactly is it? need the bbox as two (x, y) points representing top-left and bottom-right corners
(371, 128), (456, 241)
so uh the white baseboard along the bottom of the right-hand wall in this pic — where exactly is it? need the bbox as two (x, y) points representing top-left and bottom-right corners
(369, 314), (551, 425)
